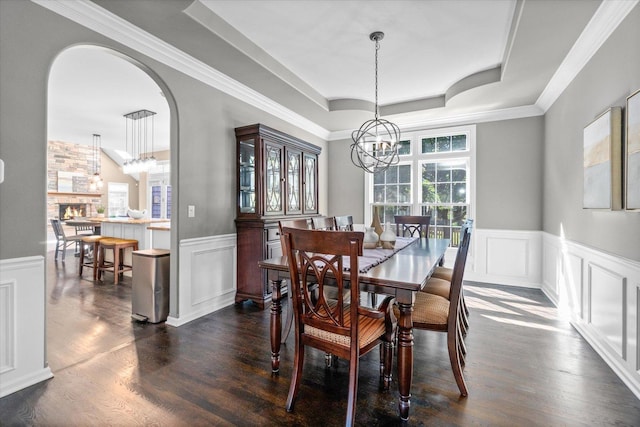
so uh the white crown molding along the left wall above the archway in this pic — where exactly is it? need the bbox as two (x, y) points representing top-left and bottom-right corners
(31, 0), (330, 140)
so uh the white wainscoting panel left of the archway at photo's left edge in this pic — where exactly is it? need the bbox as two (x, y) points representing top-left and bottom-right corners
(0, 256), (53, 397)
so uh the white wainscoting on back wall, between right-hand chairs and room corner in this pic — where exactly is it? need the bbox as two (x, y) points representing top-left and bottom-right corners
(464, 229), (542, 288)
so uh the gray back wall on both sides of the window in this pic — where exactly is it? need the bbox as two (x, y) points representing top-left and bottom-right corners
(328, 116), (544, 230)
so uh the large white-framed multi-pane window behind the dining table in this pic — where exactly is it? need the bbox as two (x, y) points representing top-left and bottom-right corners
(365, 126), (475, 247)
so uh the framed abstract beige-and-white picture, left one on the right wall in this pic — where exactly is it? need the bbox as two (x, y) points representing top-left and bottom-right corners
(582, 107), (622, 210)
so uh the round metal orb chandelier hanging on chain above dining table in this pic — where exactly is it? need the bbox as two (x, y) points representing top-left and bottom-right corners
(351, 31), (400, 173)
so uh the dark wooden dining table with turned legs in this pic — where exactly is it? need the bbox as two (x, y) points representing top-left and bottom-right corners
(258, 238), (449, 420)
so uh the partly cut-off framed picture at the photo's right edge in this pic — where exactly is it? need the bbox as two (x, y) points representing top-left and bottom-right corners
(624, 89), (640, 212)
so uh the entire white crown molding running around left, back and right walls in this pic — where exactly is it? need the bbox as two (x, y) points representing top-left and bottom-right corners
(31, 0), (640, 144)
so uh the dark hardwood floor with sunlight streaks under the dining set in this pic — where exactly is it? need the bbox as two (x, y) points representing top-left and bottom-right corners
(0, 249), (640, 426)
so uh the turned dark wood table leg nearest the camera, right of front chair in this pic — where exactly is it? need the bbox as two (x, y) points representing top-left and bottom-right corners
(398, 303), (413, 420)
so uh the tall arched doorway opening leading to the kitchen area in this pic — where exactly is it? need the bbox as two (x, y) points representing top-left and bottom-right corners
(46, 45), (176, 372)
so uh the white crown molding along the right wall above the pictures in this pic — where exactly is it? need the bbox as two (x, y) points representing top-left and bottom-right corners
(536, 0), (640, 113)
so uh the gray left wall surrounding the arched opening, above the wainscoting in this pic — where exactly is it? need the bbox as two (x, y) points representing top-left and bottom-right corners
(0, 0), (326, 262)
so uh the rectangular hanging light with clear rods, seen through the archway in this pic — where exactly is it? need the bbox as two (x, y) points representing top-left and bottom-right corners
(122, 110), (157, 174)
